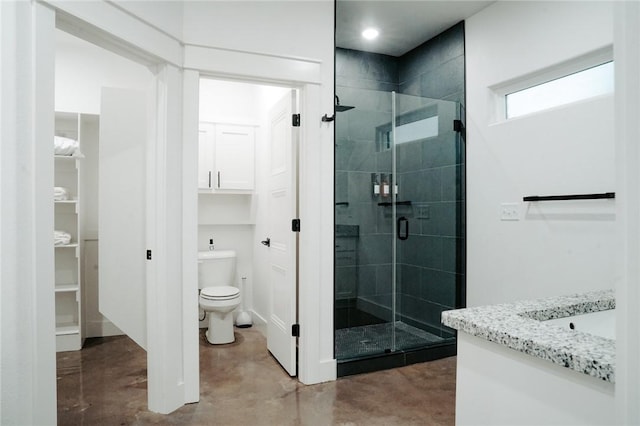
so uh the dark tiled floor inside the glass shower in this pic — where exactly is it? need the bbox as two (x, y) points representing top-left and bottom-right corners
(335, 321), (447, 360)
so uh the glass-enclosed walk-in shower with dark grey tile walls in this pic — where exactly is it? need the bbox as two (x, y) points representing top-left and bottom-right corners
(334, 87), (465, 376)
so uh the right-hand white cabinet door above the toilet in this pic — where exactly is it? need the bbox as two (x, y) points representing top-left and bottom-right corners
(214, 124), (255, 190)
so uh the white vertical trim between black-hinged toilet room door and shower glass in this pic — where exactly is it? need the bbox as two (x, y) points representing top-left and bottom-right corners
(298, 84), (337, 384)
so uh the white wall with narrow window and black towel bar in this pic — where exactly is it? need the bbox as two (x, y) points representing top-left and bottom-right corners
(465, 1), (616, 306)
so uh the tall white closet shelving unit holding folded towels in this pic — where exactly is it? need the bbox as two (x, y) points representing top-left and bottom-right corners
(54, 112), (84, 352)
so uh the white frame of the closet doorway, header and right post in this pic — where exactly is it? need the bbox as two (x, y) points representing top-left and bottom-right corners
(51, 5), (192, 414)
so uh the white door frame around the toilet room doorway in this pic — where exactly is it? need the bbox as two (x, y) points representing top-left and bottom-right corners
(183, 44), (337, 384)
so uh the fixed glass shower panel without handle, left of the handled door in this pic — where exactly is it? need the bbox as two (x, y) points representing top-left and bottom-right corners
(334, 90), (393, 360)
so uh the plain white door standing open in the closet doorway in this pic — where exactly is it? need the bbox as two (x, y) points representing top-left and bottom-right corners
(98, 88), (147, 349)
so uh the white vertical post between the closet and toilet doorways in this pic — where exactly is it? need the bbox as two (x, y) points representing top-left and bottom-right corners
(147, 64), (189, 414)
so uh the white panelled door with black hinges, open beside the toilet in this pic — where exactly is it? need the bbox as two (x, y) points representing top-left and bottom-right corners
(265, 90), (298, 376)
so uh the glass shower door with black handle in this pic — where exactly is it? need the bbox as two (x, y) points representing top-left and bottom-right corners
(391, 94), (465, 351)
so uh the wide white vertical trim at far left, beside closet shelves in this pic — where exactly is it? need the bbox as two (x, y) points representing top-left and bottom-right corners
(0, 2), (57, 425)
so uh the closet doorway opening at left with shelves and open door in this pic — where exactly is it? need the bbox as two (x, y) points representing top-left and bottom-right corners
(54, 25), (155, 412)
